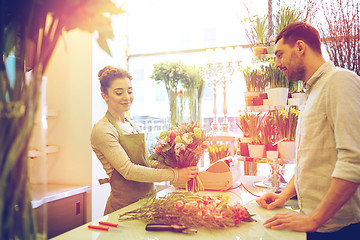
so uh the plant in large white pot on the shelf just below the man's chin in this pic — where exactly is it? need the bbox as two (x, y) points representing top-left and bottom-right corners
(266, 59), (289, 106)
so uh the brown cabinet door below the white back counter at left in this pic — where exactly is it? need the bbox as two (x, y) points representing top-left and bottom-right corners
(48, 193), (86, 238)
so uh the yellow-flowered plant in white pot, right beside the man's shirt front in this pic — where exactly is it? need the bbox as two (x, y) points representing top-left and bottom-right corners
(275, 106), (300, 159)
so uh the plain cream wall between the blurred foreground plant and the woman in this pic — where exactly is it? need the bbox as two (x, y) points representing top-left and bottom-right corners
(45, 30), (92, 219)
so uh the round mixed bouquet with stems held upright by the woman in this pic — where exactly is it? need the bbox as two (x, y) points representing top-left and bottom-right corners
(150, 123), (209, 192)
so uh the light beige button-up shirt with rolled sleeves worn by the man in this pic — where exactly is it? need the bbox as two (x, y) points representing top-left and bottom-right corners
(295, 62), (360, 232)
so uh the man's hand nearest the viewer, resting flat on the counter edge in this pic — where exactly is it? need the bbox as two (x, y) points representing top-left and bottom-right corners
(263, 212), (319, 232)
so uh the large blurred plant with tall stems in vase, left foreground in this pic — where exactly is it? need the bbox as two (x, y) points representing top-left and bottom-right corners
(0, 0), (123, 239)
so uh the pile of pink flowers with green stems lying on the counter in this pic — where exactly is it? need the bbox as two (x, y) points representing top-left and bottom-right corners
(119, 191), (255, 230)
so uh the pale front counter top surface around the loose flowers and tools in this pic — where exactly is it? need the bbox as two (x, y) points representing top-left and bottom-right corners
(53, 176), (306, 240)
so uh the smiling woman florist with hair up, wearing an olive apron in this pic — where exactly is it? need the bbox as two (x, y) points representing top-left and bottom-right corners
(91, 66), (198, 215)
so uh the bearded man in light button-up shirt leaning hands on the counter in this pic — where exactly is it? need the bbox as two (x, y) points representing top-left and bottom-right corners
(257, 22), (360, 239)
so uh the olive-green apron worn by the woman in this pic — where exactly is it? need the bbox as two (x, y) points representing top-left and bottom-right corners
(104, 112), (155, 215)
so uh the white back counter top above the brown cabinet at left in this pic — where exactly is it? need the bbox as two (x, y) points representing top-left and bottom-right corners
(31, 184), (90, 208)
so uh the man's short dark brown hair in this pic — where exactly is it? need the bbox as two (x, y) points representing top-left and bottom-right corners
(275, 22), (321, 54)
